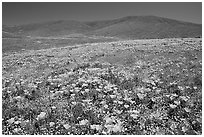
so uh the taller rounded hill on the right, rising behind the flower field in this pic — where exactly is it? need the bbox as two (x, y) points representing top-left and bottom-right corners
(87, 16), (202, 39)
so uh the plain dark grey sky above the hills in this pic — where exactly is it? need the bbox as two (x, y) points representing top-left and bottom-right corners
(2, 2), (202, 25)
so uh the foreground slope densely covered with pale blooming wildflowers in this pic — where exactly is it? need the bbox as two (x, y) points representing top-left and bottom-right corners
(2, 38), (202, 135)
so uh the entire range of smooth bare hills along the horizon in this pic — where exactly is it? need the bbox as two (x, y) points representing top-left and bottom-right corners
(3, 16), (202, 39)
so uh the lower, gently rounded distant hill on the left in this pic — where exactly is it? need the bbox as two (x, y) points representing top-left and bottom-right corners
(2, 21), (90, 37)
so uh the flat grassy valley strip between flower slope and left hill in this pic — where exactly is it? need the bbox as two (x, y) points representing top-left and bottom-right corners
(2, 37), (118, 52)
